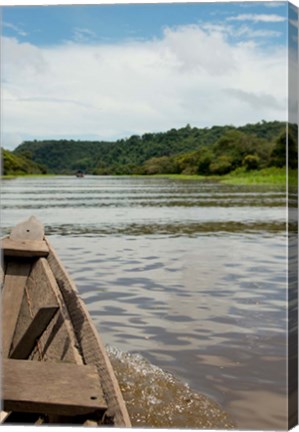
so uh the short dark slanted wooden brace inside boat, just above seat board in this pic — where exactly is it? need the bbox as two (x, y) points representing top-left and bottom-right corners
(9, 306), (59, 359)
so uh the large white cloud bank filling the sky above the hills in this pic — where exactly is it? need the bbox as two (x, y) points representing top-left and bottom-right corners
(1, 26), (287, 148)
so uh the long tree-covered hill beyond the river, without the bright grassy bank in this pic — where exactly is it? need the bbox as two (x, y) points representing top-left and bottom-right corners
(14, 121), (296, 174)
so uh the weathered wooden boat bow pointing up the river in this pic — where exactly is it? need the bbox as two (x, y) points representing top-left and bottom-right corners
(1, 217), (131, 427)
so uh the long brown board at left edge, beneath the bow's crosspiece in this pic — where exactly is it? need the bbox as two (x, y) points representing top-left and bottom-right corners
(2, 262), (31, 357)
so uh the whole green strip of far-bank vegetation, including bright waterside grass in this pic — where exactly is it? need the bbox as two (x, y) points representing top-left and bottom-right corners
(3, 121), (298, 183)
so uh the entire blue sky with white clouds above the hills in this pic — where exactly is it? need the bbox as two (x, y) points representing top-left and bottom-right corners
(1, 0), (298, 149)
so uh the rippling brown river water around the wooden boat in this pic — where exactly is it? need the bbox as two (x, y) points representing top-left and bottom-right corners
(1, 176), (287, 430)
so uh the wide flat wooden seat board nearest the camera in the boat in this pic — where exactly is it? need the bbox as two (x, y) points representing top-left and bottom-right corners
(2, 359), (107, 415)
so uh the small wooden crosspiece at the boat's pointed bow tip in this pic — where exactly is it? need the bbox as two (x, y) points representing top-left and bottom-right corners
(1, 237), (49, 257)
